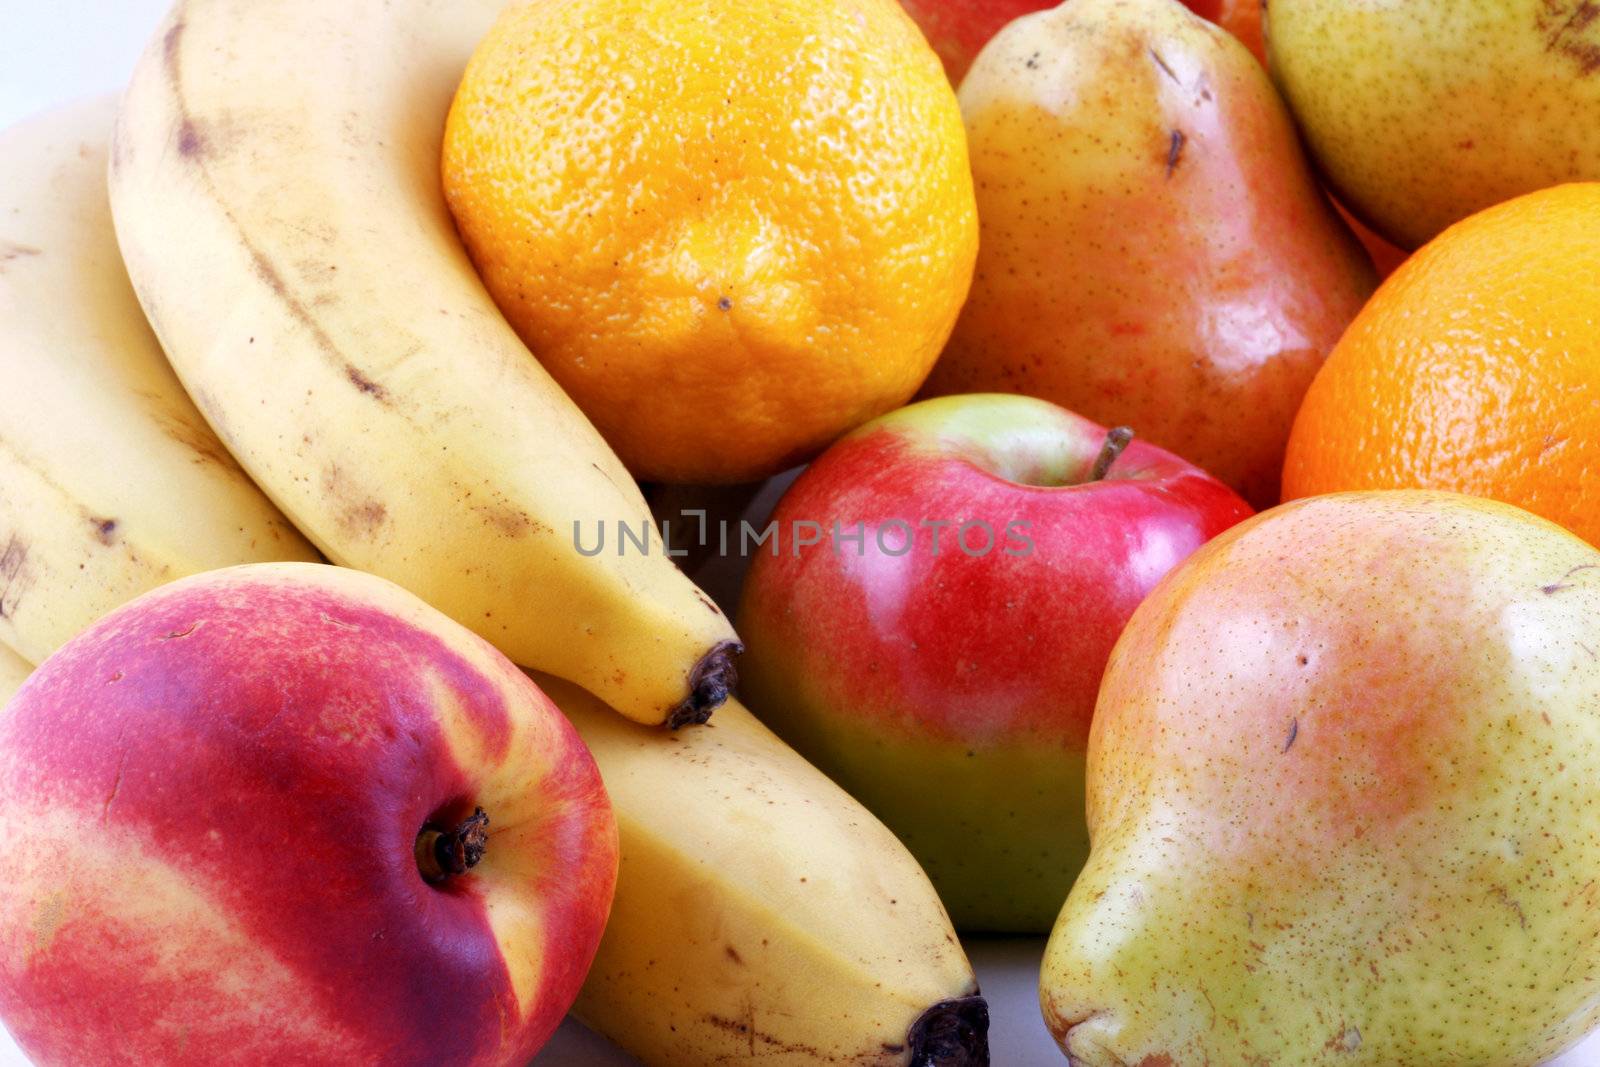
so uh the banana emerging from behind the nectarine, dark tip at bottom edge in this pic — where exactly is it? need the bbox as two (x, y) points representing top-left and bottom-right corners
(534, 675), (989, 1067)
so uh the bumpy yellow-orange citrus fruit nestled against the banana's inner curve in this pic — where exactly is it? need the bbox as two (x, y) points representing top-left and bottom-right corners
(443, 0), (978, 483)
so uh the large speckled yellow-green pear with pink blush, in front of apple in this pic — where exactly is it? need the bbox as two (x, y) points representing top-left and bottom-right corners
(1042, 491), (1600, 1067)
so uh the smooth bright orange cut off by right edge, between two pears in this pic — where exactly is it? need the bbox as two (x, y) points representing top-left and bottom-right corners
(1283, 182), (1600, 544)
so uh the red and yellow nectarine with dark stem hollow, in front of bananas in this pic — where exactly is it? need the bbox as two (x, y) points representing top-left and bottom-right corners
(0, 563), (618, 1067)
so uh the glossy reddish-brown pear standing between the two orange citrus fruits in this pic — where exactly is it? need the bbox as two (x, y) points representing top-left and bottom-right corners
(925, 0), (1376, 507)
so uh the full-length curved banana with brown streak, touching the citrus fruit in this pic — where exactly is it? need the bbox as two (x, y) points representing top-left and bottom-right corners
(110, 0), (738, 725)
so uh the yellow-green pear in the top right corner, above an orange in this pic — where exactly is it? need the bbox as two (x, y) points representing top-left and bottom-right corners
(1267, 0), (1600, 248)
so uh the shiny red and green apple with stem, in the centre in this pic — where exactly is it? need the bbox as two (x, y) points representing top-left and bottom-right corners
(739, 395), (1251, 933)
